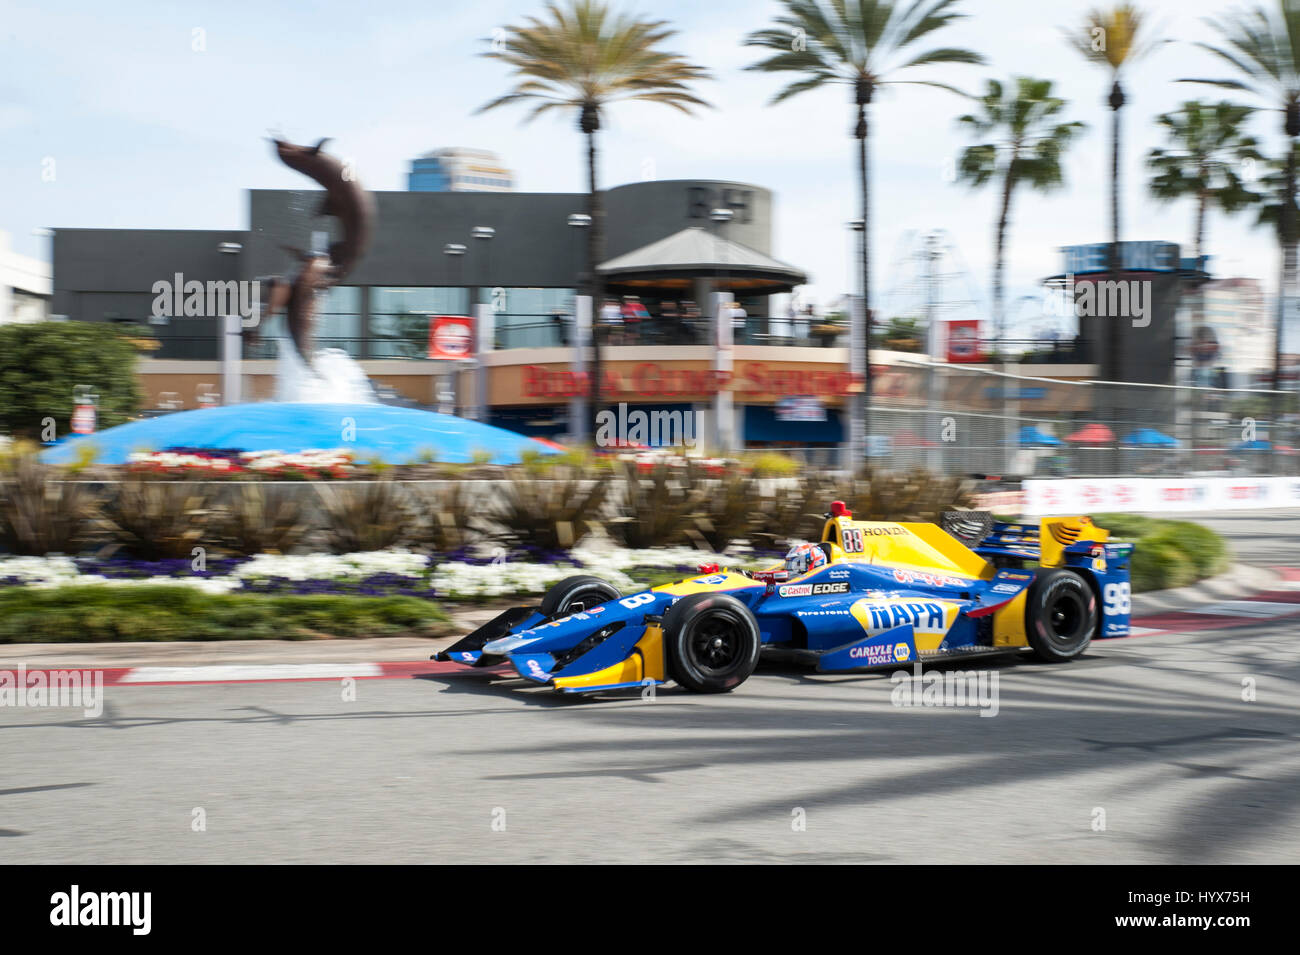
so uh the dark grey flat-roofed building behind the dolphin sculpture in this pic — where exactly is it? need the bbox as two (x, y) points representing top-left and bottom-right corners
(51, 181), (806, 360)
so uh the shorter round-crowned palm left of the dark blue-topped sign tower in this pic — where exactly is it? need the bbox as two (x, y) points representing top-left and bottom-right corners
(957, 77), (1084, 348)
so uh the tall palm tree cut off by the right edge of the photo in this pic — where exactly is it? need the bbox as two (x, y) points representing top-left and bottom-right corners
(1182, 0), (1300, 462)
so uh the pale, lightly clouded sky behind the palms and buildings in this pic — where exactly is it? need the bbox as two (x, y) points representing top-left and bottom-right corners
(0, 0), (1281, 337)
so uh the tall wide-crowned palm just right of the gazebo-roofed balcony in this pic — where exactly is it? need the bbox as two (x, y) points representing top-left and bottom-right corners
(745, 0), (984, 462)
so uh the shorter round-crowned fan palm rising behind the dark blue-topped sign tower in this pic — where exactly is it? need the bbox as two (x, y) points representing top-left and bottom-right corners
(1147, 100), (1264, 268)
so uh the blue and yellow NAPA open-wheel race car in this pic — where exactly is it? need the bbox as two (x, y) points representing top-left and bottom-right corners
(436, 502), (1132, 693)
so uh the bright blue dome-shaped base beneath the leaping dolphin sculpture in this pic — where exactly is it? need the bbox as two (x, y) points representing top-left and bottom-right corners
(43, 401), (559, 464)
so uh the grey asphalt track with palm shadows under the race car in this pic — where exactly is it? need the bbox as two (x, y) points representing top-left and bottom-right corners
(0, 516), (1300, 863)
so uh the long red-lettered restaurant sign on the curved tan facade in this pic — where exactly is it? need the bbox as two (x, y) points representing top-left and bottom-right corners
(520, 361), (861, 398)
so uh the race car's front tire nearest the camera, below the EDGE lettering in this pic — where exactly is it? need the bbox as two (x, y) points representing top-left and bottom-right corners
(663, 594), (762, 693)
